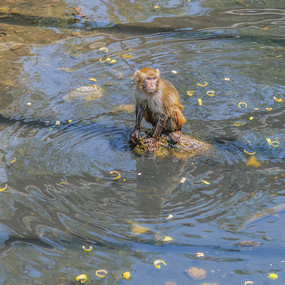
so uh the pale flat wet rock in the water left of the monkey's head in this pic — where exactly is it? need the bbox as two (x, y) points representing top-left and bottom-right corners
(63, 84), (104, 101)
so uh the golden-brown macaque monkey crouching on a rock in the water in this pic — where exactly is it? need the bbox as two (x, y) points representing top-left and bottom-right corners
(130, 68), (186, 153)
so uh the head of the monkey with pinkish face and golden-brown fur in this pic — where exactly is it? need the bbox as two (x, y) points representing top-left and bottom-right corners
(134, 67), (160, 93)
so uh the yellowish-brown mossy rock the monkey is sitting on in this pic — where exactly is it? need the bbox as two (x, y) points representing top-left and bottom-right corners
(134, 134), (212, 159)
